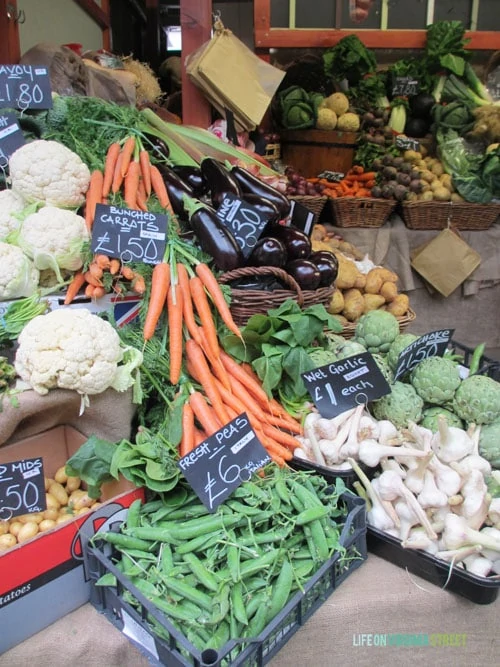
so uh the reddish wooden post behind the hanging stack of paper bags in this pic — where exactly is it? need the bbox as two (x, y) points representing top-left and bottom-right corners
(180, 0), (212, 128)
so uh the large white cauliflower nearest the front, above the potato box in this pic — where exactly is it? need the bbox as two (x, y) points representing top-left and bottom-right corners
(14, 308), (142, 396)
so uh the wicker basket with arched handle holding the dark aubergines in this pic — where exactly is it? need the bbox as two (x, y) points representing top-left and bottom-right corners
(219, 266), (334, 326)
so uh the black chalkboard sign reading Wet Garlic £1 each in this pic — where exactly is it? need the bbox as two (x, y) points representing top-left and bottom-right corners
(302, 352), (391, 419)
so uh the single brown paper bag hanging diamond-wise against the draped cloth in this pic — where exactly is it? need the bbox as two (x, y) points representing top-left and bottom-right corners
(411, 228), (481, 297)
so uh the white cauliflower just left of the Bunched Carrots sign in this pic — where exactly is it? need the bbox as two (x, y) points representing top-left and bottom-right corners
(13, 206), (90, 281)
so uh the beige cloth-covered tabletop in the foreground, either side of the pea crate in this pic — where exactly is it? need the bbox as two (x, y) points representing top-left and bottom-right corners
(0, 554), (500, 667)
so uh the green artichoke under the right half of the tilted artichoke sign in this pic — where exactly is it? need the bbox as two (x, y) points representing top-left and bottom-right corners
(410, 357), (462, 405)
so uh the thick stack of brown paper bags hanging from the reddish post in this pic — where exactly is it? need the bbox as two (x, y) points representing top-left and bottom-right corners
(186, 22), (285, 130)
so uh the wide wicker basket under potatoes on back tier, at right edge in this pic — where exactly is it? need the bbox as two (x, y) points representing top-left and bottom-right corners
(402, 201), (500, 231)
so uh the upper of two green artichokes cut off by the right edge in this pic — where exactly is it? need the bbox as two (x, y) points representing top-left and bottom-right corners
(453, 375), (500, 424)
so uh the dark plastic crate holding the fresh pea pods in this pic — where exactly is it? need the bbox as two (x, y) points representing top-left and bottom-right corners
(86, 493), (367, 667)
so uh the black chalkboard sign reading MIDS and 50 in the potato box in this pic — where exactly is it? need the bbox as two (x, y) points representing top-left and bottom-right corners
(0, 457), (47, 521)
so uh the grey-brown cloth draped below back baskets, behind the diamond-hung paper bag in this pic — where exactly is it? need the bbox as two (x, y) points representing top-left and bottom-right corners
(325, 213), (500, 348)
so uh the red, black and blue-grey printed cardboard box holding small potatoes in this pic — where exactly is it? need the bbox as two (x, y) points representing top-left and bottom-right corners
(0, 426), (144, 654)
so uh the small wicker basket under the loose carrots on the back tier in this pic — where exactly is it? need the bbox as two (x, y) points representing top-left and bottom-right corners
(330, 197), (397, 227)
